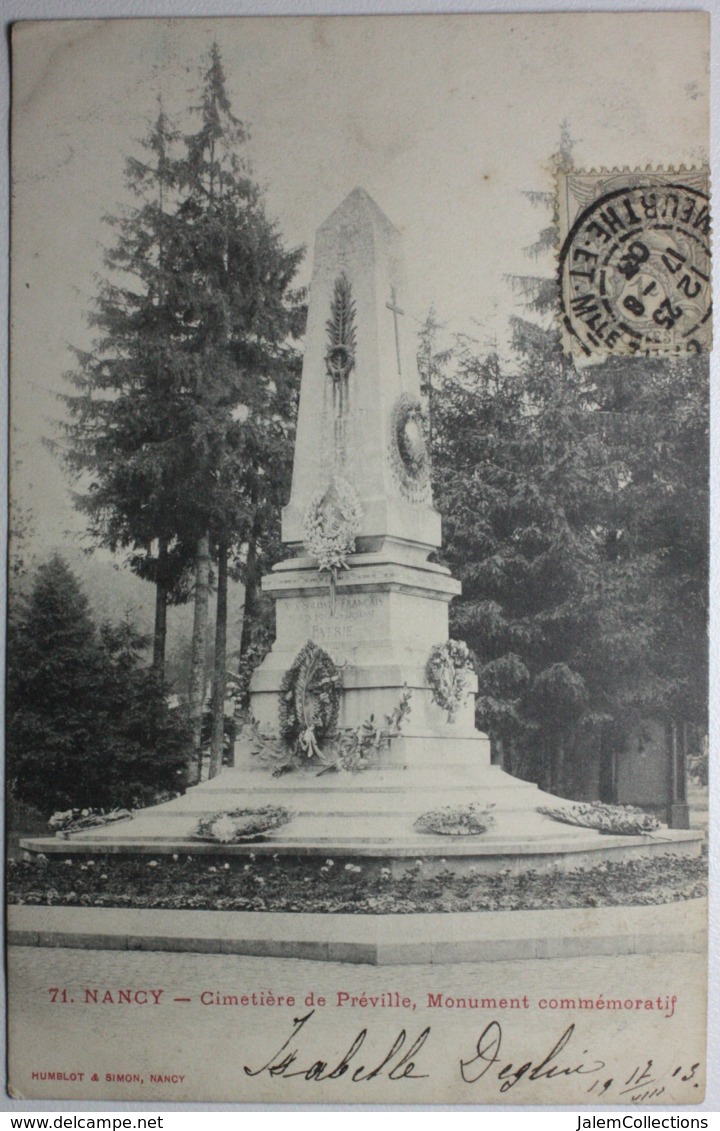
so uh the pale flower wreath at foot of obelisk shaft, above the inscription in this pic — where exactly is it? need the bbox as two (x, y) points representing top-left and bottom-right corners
(303, 477), (363, 612)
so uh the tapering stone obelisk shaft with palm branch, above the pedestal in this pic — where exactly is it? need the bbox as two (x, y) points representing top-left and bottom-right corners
(283, 189), (440, 556)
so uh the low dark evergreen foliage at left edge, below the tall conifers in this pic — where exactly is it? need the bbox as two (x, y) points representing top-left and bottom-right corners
(8, 555), (189, 812)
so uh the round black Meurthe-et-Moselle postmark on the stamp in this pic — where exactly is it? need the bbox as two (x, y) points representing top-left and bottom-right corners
(559, 182), (712, 357)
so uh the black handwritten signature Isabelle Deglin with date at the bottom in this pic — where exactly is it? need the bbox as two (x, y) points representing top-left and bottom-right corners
(244, 1009), (700, 1103)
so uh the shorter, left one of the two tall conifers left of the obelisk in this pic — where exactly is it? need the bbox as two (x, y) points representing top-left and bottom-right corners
(63, 111), (191, 674)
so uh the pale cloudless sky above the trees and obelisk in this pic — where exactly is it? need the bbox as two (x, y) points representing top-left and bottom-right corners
(11, 11), (709, 546)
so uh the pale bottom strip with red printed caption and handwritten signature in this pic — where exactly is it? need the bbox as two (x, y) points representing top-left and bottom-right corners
(9, 947), (705, 1107)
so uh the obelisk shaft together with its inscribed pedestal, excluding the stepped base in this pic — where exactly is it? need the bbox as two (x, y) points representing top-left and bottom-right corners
(252, 189), (487, 760)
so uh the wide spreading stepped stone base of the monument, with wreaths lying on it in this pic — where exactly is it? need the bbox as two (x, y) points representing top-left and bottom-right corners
(21, 766), (703, 873)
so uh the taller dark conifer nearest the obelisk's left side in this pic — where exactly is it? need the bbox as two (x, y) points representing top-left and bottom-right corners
(177, 44), (304, 775)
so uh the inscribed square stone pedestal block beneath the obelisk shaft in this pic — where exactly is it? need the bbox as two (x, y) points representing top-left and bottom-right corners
(252, 543), (474, 737)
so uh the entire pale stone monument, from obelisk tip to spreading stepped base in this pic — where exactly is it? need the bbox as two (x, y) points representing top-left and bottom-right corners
(25, 189), (701, 870)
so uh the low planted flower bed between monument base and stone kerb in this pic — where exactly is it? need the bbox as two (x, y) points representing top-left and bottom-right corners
(6, 854), (708, 915)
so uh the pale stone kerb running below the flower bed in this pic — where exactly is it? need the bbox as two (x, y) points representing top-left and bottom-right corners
(8, 899), (708, 966)
